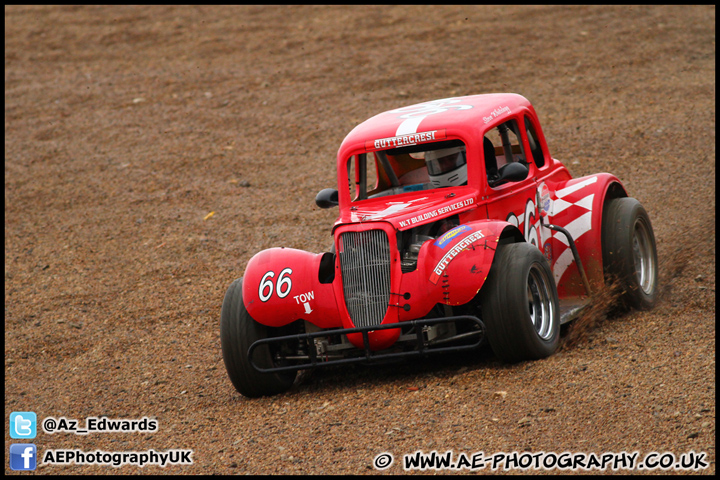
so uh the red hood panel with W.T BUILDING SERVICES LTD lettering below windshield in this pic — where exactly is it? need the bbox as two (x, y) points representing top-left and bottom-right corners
(336, 187), (477, 230)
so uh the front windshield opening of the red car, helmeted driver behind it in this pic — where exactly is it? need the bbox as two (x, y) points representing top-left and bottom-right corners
(347, 140), (467, 201)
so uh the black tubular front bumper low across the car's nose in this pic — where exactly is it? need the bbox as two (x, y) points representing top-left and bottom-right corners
(248, 315), (485, 373)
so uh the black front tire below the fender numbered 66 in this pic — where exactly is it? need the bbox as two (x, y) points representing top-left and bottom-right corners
(220, 278), (297, 398)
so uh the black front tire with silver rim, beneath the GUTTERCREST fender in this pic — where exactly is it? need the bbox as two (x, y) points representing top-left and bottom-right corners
(480, 243), (560, 363)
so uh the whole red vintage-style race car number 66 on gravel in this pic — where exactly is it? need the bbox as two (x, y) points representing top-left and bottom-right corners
(220, 94), (658, 397)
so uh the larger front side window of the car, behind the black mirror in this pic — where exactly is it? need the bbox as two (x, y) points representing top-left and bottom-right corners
(483, 120), (527, 186)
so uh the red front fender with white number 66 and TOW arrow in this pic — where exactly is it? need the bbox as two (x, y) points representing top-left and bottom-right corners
(243, 248), (341, 328)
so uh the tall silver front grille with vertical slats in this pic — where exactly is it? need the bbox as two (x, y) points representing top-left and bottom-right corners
(339, 230), (390, 327)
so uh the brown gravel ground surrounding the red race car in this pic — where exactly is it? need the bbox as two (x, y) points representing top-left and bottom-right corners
(5, 6), (716, 474)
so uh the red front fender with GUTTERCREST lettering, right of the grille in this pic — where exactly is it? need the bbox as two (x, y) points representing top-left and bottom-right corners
(399, 220), (521, 320)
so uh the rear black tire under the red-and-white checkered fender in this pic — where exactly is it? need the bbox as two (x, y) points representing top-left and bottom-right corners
(602, 198), (658, 310)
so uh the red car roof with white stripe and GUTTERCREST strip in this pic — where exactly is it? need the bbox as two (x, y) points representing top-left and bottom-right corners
(338, 93), (532, 156)
